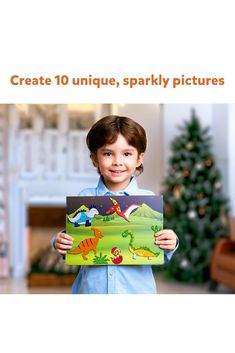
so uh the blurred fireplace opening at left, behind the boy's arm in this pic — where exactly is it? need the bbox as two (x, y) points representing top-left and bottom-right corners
(27, 206), (79, 287)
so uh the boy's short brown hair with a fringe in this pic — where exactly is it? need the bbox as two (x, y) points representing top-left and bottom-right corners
(86, 115), (147, 174)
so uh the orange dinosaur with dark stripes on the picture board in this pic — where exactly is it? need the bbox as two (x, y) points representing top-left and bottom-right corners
(69, 228), (104, 260)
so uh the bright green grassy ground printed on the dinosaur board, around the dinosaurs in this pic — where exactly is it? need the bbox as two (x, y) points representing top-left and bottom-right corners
(66, 217), (163, 265)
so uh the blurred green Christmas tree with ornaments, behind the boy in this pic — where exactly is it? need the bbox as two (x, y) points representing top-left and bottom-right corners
(164, 111), (228, 283)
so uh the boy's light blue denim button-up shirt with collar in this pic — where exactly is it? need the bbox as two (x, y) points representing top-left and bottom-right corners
(72, 177), (174, 294)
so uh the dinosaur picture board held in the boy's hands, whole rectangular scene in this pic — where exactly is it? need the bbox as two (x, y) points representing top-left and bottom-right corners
(65, 195), (164, 265)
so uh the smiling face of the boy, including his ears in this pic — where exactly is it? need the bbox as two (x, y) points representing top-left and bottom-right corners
(91, 134), (144, 192)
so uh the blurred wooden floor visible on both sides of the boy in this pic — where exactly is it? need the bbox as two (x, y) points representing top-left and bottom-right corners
(0, 273), (234, 294)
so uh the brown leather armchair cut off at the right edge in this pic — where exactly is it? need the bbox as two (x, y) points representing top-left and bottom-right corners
(210, 218), (235, 291)
